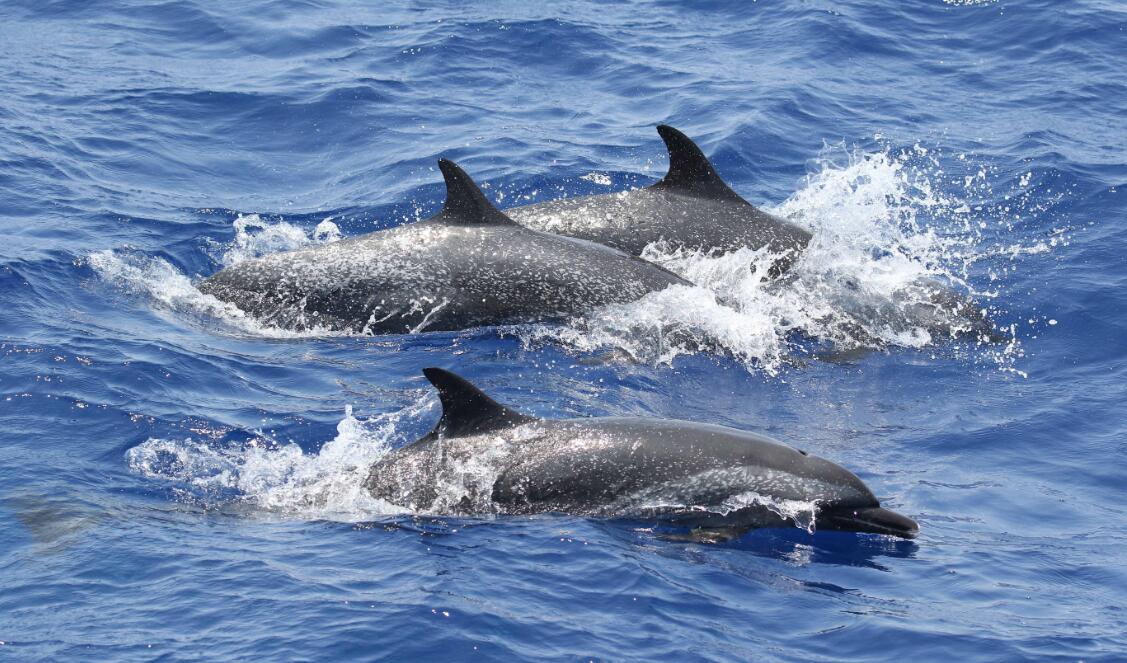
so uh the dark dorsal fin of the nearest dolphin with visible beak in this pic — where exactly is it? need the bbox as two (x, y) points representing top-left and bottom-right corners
(423, 368), (534, 436)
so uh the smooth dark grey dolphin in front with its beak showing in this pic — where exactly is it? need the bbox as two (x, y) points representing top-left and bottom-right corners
(364, 369), (919, 538)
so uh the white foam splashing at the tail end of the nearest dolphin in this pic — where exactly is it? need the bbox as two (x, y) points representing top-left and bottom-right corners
(126, 394), (536, 522)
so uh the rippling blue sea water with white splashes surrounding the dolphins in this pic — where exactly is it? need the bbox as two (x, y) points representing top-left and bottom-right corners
(0, 0), (1127, 661)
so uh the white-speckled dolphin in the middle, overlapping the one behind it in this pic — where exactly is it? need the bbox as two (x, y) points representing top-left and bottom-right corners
(198, 159), (689, 334)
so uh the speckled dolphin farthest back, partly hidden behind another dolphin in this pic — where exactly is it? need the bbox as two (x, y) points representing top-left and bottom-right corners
(506, 124), (810, 276)
